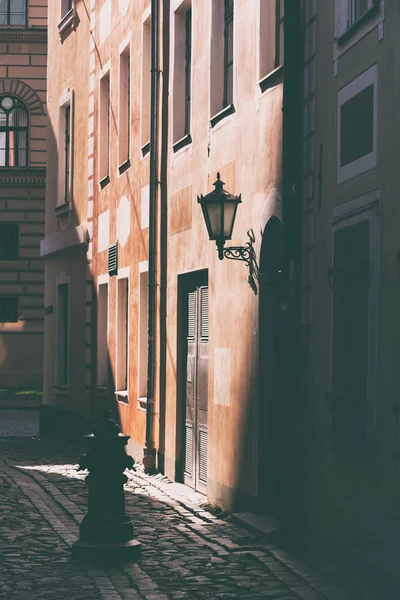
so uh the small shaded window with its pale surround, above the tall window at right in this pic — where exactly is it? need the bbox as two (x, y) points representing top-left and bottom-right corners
(337, 65), (378, 183)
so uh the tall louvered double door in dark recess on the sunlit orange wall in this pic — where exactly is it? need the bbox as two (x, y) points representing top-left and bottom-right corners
(178, 271), (208, 493)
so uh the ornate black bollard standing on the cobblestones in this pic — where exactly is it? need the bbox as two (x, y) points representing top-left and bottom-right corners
(72, 410), (141, 560)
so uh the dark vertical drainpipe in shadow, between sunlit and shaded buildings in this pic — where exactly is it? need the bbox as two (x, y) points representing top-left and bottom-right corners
(281, 0), (305, 535)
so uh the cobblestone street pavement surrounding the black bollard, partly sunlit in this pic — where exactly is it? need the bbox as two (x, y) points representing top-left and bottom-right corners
(0, 438), (400, 600)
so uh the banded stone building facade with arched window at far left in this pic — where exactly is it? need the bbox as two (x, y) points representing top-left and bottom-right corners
(0, 0), (47, 389)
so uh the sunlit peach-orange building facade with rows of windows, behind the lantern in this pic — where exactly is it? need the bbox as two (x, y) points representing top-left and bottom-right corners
(41, 0), (301, 515)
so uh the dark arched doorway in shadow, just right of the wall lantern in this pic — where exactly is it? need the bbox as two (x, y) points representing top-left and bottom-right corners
(258, 217), (285, 518)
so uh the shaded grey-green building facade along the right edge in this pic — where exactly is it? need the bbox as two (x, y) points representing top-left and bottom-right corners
(303, 0), (400, 574)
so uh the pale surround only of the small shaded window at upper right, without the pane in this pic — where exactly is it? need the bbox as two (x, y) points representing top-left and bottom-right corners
(336, 63), (378, 184)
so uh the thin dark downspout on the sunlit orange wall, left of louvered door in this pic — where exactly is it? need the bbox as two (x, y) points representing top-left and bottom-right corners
(143, 0), (160, 472)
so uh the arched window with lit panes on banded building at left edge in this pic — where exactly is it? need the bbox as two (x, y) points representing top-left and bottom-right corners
(0, 96), (28, 167)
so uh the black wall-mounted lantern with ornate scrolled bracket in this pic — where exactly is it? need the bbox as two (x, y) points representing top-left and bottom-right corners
(197, 173), (258, 293)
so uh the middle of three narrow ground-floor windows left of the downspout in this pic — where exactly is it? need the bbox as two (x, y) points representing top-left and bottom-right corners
(117, 278), (129, 401)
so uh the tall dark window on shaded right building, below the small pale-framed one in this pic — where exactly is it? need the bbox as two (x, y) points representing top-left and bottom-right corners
(330, 194), (379, 439)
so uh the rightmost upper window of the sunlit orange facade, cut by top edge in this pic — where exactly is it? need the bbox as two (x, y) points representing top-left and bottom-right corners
(259, 0), (284, 79)
